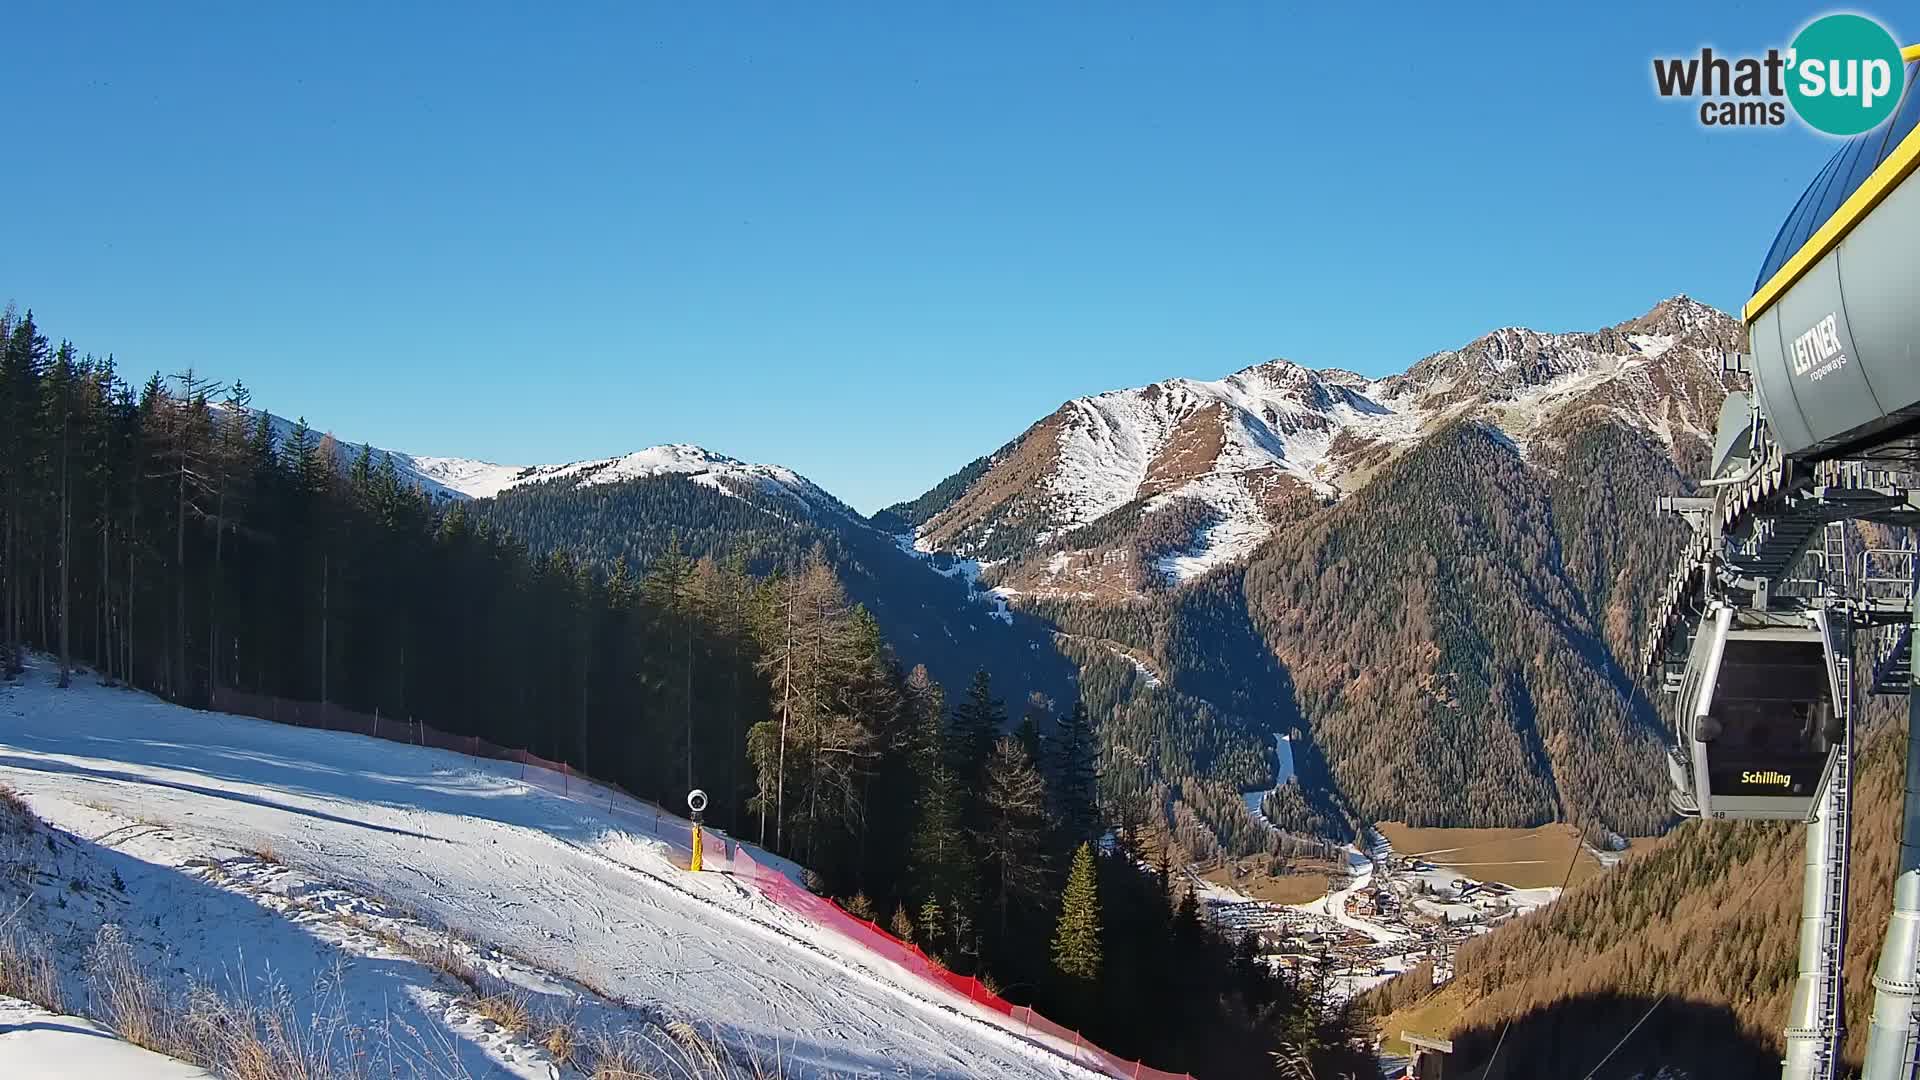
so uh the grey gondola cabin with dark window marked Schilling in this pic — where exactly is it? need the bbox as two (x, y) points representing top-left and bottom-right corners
(1668, 603), (1841, 821)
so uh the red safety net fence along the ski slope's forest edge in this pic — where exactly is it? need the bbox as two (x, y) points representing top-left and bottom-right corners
(209, 686), (1192, 1080)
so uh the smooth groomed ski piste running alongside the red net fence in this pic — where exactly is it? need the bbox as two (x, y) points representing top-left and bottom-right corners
(0, 661), (1102, 1080)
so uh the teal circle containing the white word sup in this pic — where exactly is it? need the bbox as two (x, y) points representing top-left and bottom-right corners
(1788, 15), (1907, 135)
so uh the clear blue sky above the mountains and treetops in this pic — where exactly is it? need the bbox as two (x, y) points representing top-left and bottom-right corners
(0, 0), (1889, 509)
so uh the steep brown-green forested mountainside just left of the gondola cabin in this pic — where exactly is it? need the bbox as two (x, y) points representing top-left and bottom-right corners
(1246, 417), (1672, 834)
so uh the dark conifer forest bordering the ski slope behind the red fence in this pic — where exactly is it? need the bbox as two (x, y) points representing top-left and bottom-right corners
(0, 309), (1382, 1076)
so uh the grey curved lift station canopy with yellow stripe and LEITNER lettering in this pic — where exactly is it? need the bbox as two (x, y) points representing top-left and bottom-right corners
(1743, 56), (1920, 461)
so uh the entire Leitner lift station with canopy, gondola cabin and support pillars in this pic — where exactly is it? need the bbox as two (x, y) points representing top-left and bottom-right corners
(1635, 46), (1920, 1080)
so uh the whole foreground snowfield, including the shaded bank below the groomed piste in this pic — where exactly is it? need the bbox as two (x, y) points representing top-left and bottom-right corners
(0, 657), (1104, 1080)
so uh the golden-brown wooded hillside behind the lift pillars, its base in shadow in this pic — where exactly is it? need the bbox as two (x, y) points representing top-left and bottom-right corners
(1371, 703), (1907, 1080)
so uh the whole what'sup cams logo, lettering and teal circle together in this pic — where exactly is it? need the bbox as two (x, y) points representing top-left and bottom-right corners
(1653, 15), (1907, 136)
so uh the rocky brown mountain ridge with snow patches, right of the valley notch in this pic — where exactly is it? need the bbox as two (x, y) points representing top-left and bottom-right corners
(898, 296), (1738, 592)
